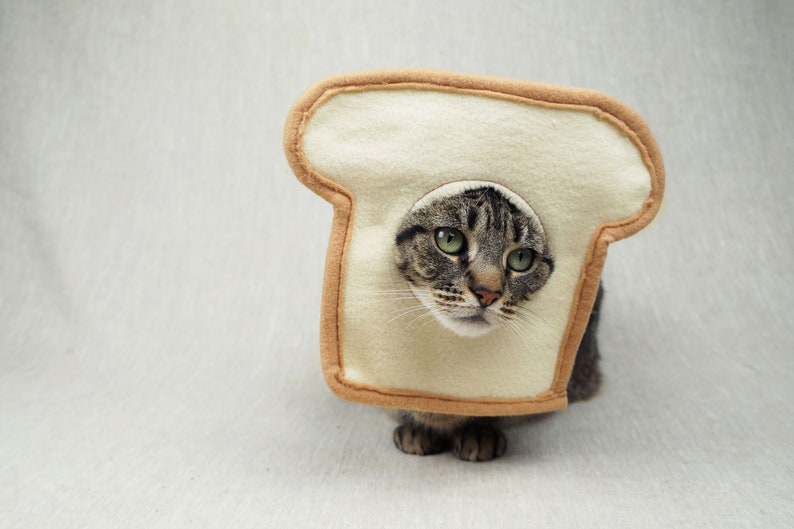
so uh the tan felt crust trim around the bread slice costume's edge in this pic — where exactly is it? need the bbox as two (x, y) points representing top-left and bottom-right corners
(284, 69), (664, 416)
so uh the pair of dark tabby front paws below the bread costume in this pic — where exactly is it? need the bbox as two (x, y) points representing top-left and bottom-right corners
(394, 411), (507, 461)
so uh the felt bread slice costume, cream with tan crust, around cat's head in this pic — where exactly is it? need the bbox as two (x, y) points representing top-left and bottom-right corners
(284, 70), (664, 416)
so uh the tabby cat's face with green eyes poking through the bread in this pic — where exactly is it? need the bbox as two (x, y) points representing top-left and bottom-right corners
(395, 185), (554, 336)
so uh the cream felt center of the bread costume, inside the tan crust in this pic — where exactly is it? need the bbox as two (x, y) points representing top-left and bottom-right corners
(302, 87), (651, 399)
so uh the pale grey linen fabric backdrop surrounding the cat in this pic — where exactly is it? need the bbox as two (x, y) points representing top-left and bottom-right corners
(0, 0), (794, 529)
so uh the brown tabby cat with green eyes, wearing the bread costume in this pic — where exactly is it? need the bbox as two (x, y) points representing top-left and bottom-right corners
(393, 185), (603, 461)
